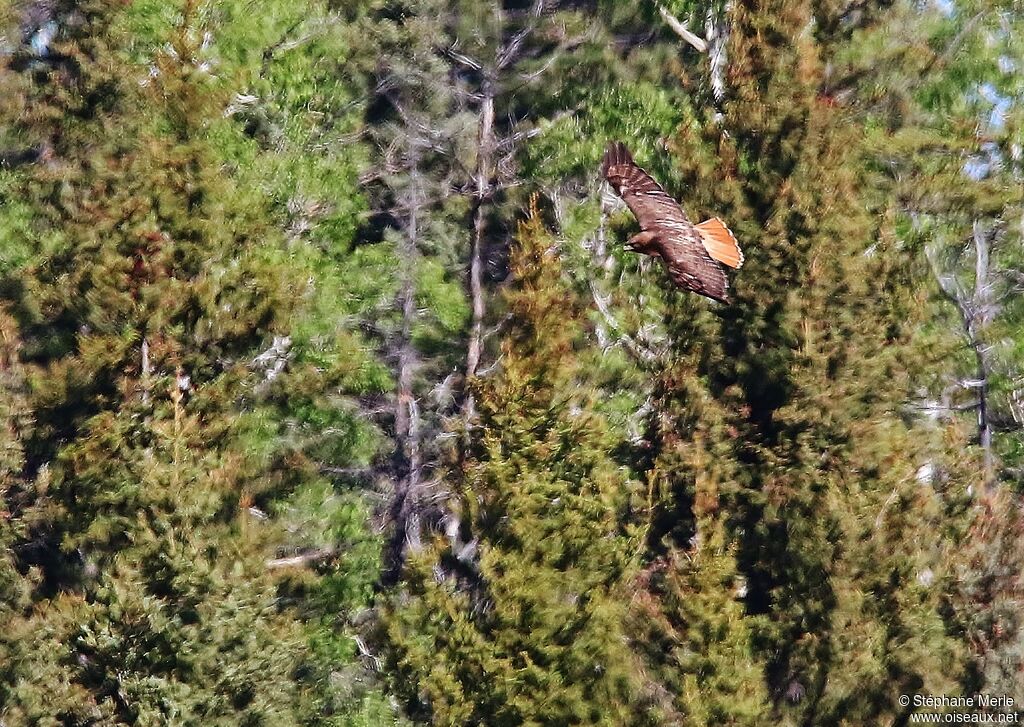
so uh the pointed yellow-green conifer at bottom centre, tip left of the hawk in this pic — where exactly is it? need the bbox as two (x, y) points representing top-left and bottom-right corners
(387, 207), (641, 725)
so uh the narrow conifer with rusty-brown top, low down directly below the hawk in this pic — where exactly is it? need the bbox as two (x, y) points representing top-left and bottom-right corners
(633, 356), (769, 725)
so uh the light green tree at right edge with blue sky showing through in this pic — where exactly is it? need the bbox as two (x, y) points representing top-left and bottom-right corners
(874, 3), (1022, 488)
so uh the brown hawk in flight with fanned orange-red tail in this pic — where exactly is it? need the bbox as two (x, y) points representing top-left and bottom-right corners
(601, 141), (743, 303)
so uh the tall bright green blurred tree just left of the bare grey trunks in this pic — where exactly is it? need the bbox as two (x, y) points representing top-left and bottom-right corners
(205, 2), (413, 726)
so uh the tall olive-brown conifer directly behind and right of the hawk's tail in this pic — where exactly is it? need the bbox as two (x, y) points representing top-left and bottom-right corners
(630, 1), (959, 725)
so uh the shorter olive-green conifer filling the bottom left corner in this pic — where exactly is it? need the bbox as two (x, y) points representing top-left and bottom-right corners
(7, 381), (304, 725)
